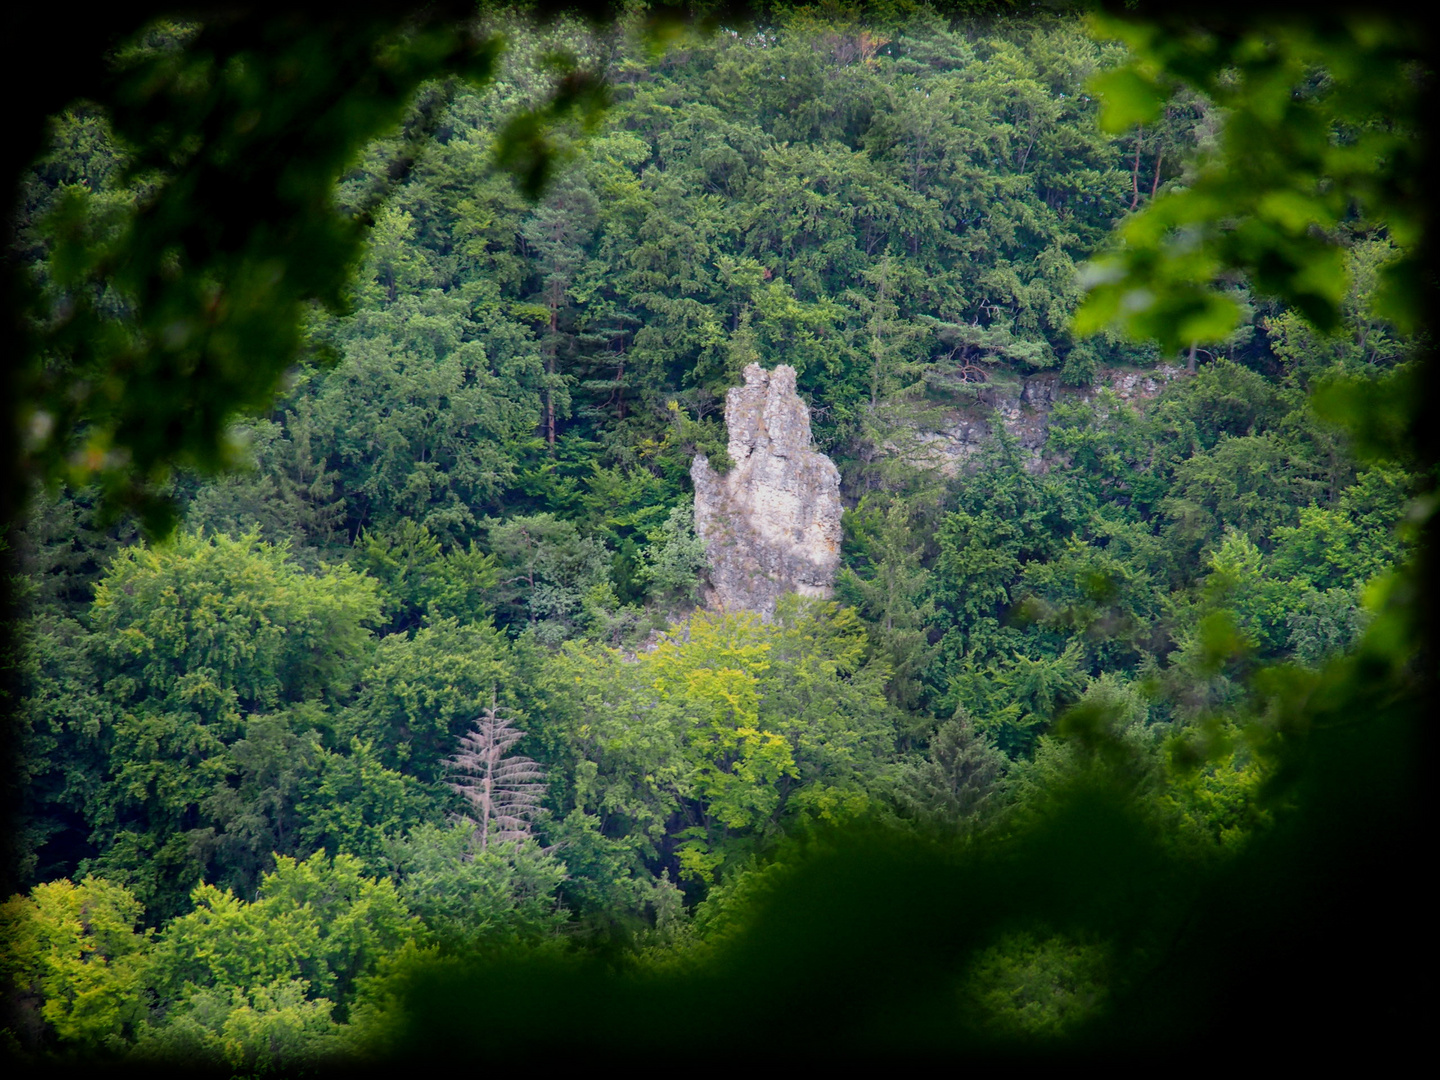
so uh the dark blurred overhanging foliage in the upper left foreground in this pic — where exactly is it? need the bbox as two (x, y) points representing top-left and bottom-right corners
(2, 3), (665, 536)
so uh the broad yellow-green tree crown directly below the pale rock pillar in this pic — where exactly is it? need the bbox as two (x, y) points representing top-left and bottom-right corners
(533, 596), (894, 881)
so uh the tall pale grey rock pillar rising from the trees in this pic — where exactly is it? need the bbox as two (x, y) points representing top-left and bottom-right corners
(690, 364), (841, 616)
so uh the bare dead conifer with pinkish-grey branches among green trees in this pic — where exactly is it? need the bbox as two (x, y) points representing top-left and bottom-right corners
(449, 703), (544, 851)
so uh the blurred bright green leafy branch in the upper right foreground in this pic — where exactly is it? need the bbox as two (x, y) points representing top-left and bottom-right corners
(1076, 12), (1428, 351)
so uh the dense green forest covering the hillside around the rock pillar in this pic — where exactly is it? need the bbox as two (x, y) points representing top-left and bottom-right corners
(0, 7), (1428, 1071)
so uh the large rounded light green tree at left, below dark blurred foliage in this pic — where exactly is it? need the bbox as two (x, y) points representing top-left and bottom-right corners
(86, 534), (380, 914)
